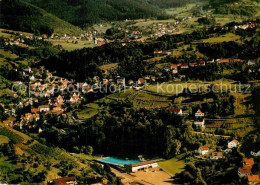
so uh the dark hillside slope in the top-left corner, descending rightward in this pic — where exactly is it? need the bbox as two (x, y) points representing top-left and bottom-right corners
(0, 0), (82, 34)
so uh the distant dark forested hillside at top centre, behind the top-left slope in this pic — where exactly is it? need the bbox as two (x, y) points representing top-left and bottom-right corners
(23, 0), (162, 27)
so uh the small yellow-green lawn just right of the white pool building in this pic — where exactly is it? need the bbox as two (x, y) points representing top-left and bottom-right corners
(158, 158), (185, 176)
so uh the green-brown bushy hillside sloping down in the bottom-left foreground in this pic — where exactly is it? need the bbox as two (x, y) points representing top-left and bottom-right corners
(0, 123), (120, 184)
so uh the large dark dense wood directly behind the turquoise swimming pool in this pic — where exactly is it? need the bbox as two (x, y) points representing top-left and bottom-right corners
(38, 102), (200, 158)
